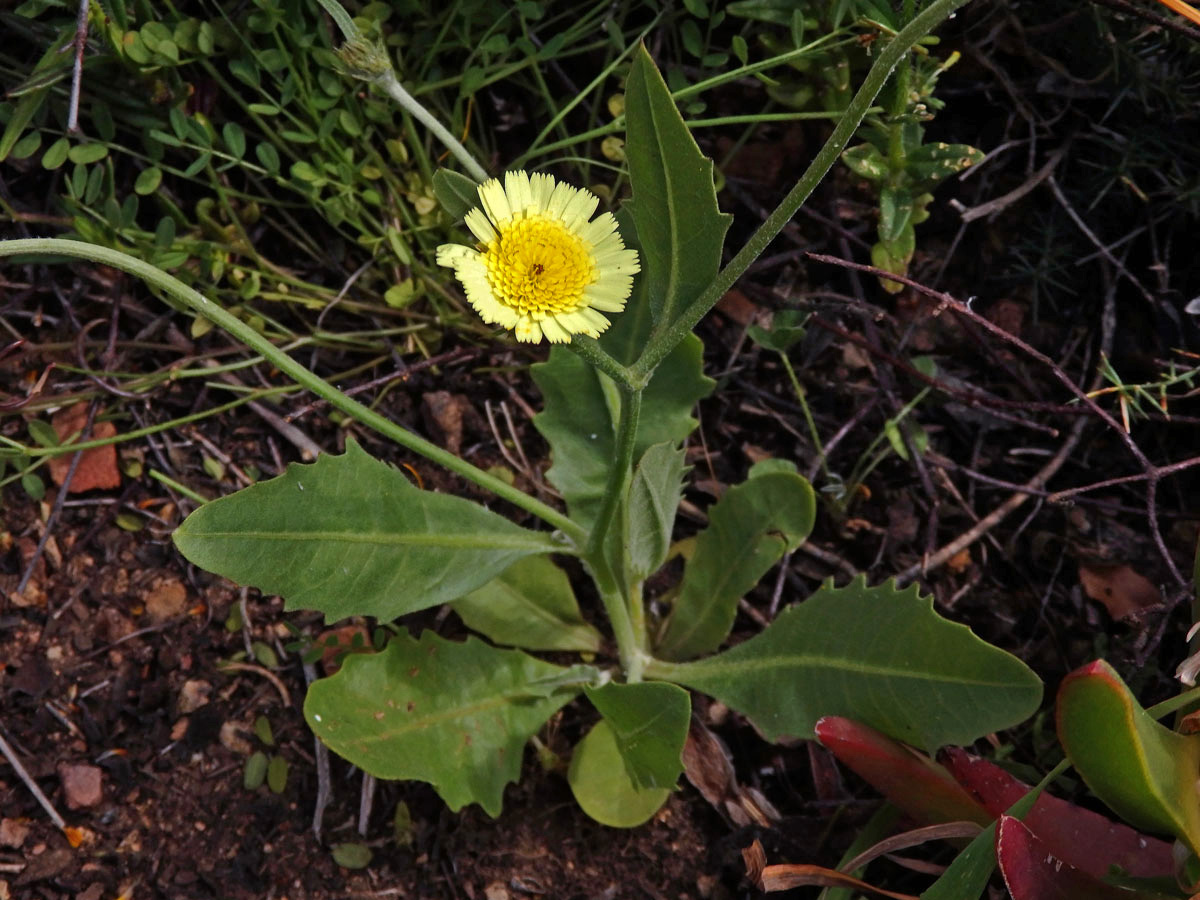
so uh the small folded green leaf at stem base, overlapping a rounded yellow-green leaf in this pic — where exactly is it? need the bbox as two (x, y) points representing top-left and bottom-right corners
(584, 682), (691, 788)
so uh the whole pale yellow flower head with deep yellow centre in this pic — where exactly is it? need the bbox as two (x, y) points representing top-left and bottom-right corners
(438, 172), (641, 343)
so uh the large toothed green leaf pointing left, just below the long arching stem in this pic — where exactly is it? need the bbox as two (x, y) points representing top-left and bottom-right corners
(174, 440), (562, 622)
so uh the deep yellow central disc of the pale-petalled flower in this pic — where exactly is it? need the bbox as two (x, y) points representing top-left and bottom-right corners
(482, 215), (596, 317)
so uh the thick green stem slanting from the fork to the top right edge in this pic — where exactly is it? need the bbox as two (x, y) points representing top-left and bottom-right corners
(631, 0), (967, 378)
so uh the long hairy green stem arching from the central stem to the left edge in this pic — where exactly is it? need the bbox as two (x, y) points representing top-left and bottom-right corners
(0, 238), (588, 542)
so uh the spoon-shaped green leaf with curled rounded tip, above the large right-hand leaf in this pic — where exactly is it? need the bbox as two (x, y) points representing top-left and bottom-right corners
(656, 460), (816, 659)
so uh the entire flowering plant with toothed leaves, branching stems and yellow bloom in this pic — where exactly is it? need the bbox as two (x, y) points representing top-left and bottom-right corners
(0, 0), (1042, 827)
